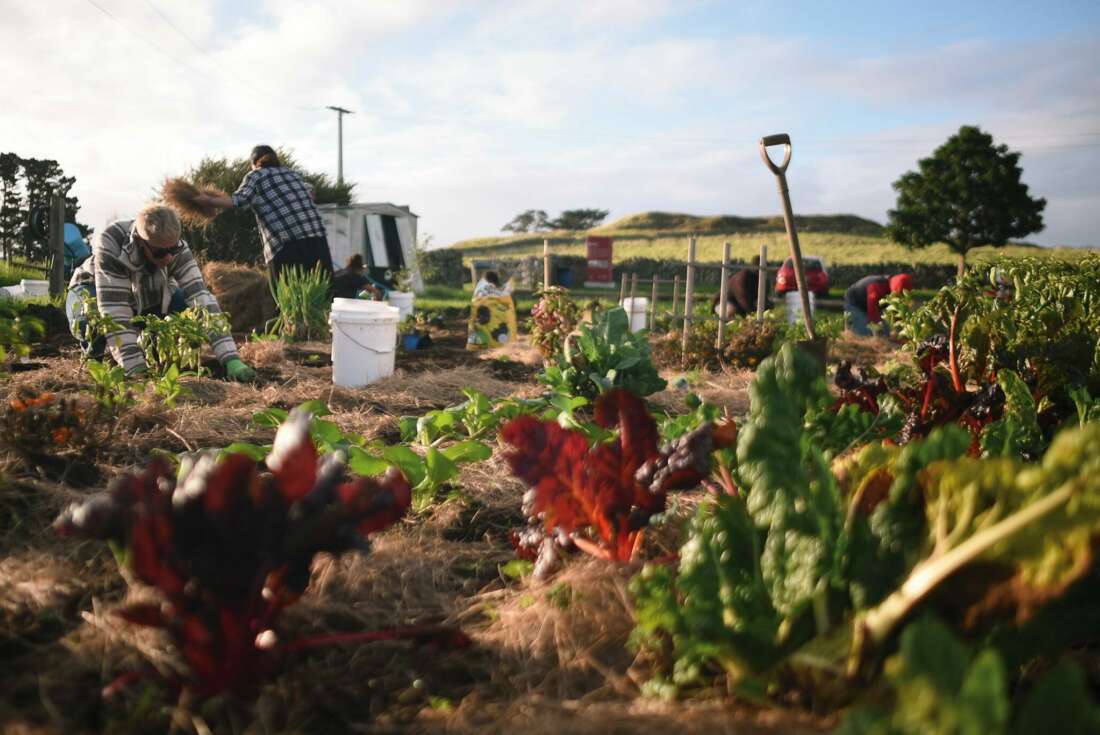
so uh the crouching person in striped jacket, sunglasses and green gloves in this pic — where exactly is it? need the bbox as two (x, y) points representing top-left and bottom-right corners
(65, 205), (256, 382)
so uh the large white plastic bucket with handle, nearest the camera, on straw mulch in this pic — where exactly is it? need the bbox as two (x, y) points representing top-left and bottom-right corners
(329, 298), (399, 388)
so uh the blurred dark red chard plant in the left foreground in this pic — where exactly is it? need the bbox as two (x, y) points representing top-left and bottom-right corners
(54, 413), (411, 700)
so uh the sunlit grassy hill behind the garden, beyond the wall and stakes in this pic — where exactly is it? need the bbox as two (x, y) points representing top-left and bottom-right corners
(451, 212), (1093, 264)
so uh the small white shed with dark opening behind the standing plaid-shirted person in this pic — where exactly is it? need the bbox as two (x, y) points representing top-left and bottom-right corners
(317, 202), (424, 293)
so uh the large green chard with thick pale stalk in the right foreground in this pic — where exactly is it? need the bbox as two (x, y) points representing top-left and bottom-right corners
(631, 345), (1100, 704)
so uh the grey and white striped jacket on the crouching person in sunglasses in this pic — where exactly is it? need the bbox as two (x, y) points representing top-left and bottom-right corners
(69, 220), (238, 374)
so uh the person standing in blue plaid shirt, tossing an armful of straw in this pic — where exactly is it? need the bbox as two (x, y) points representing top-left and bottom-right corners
(195, 145), (332, 286)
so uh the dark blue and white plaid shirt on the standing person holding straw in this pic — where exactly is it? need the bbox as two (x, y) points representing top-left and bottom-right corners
(233, 166), (325, 263)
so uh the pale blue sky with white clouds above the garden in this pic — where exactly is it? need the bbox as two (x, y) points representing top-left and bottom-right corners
(0, 0), (1100, 246)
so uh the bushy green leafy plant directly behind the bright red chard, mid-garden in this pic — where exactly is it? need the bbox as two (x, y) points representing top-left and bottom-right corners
(539, 307), (667, 398)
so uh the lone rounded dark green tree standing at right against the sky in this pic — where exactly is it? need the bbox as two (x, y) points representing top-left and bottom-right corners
(887, 125), (1046, 275)
